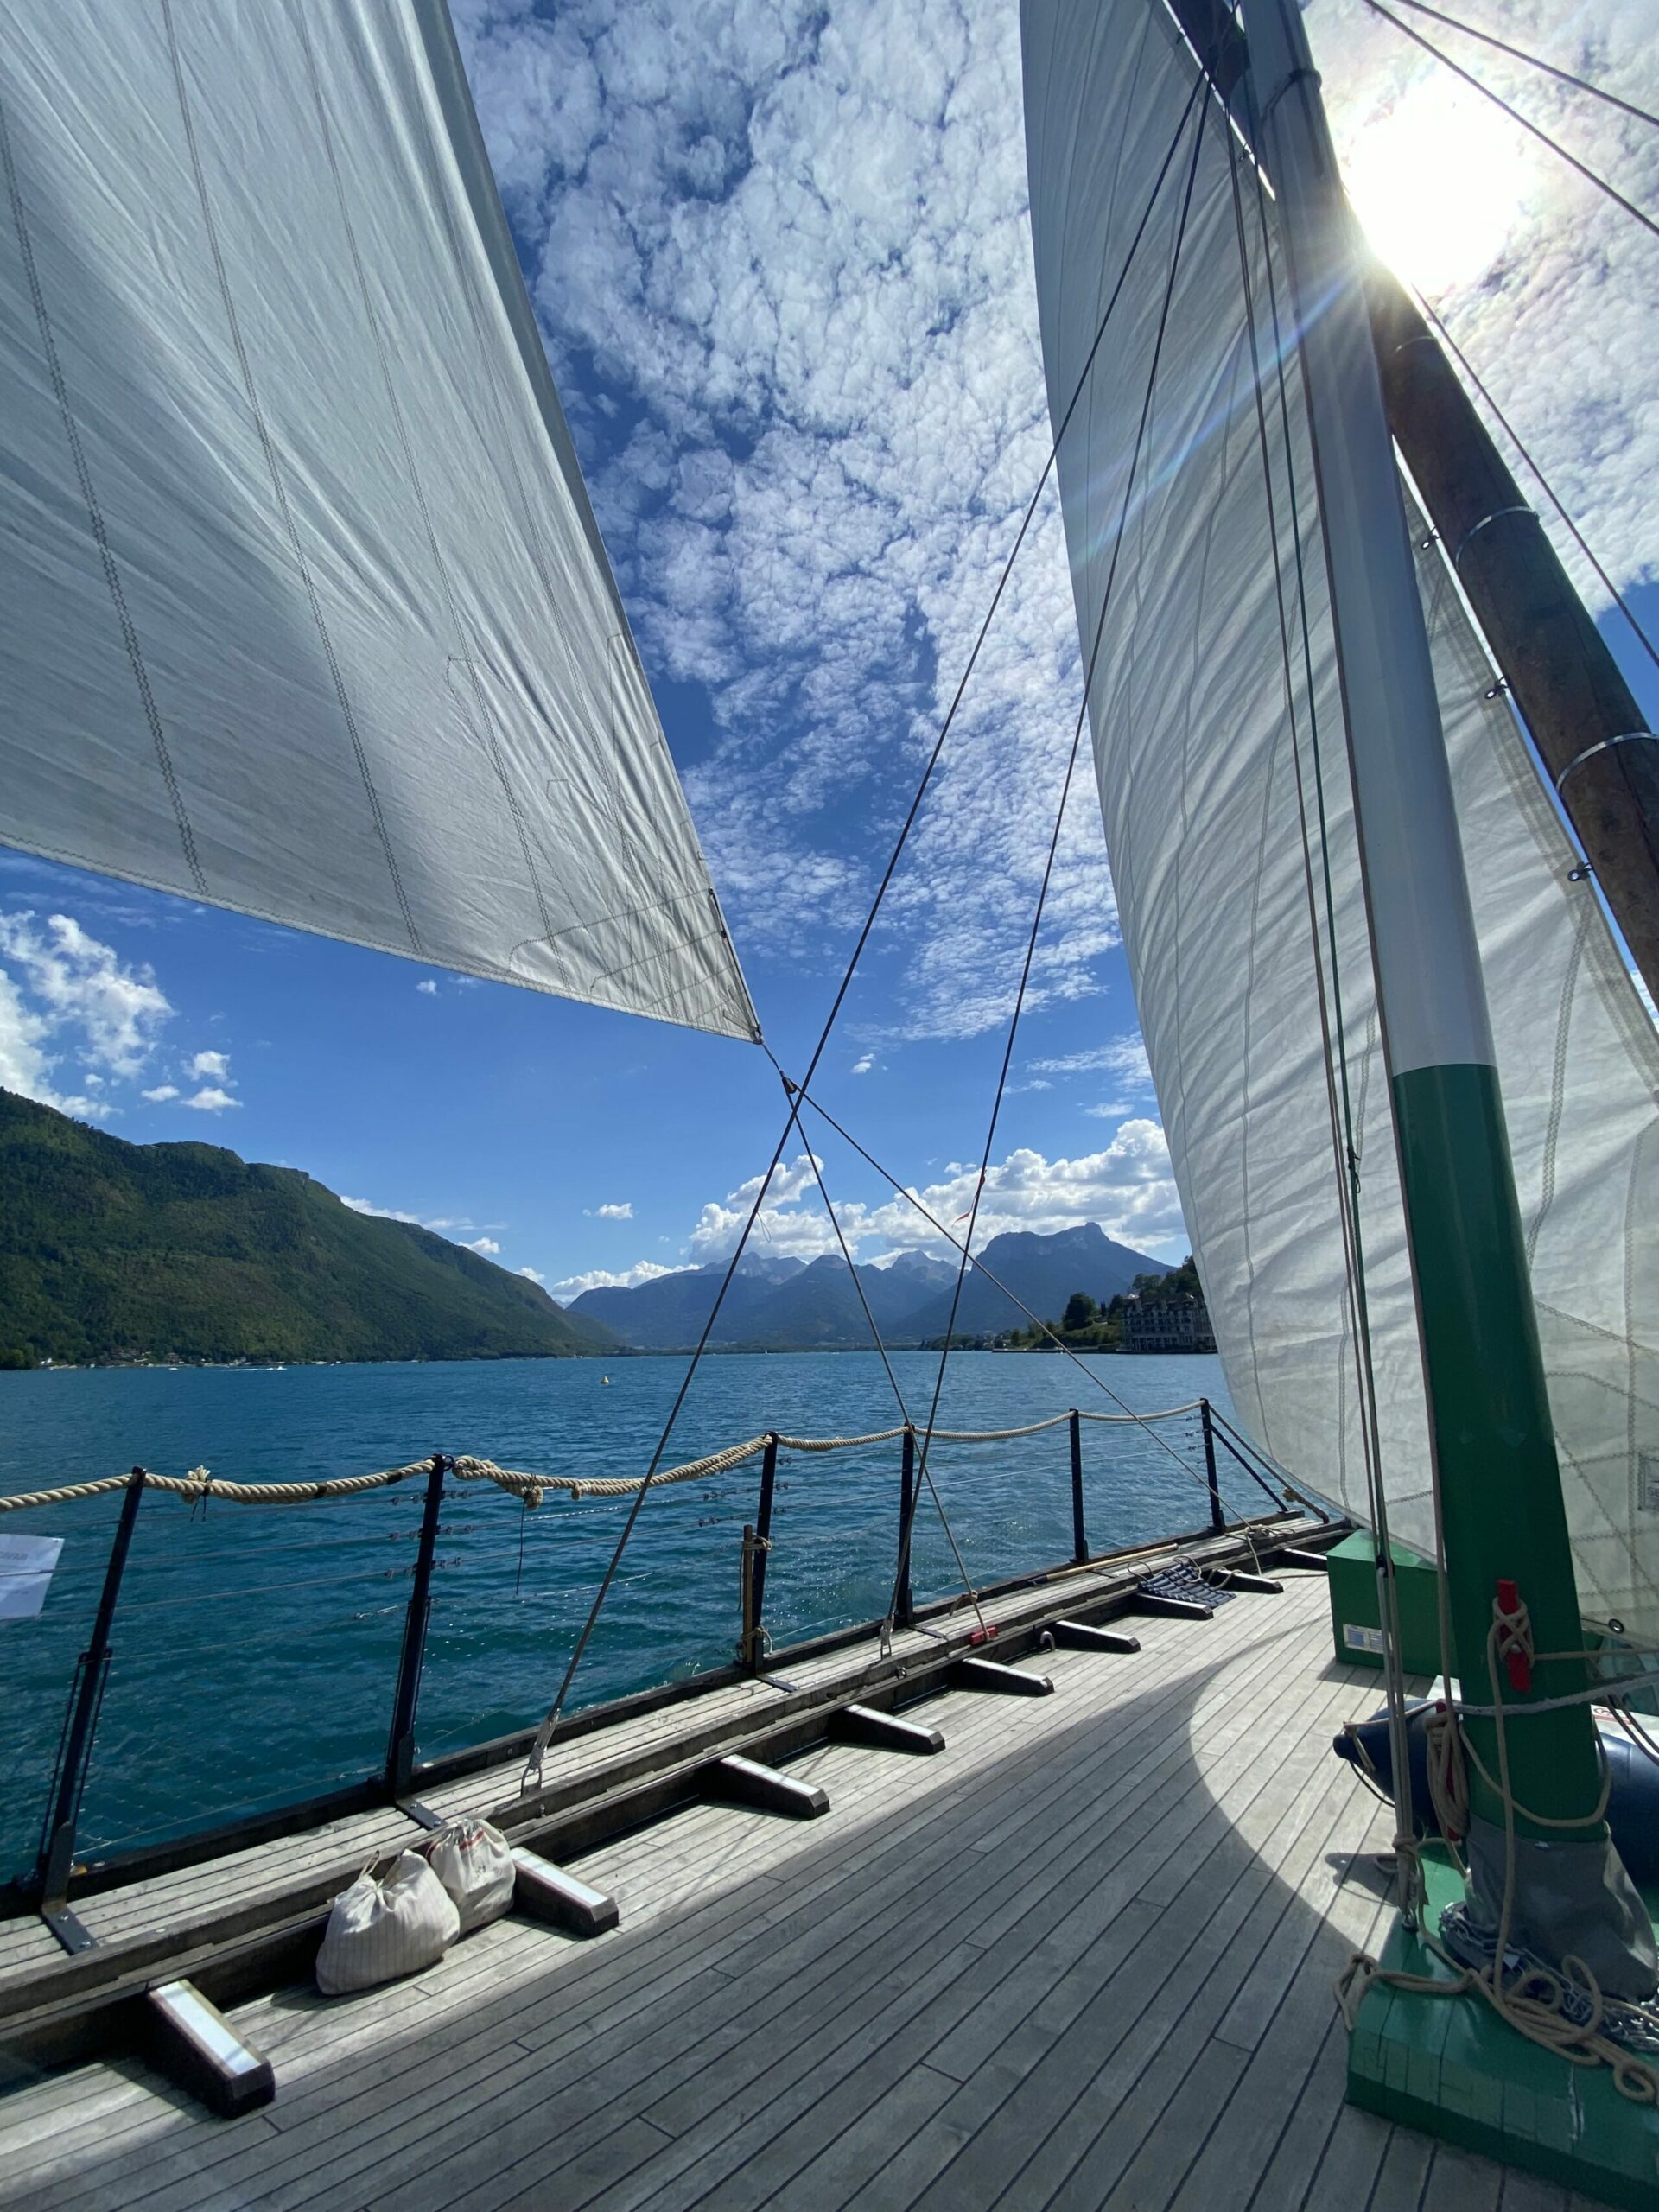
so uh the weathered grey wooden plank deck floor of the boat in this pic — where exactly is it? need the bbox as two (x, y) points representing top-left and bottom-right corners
(0, 1575), (1610, 2212)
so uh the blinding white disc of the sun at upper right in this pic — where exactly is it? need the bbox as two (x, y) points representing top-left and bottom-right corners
(1343, 79), (1526, 294)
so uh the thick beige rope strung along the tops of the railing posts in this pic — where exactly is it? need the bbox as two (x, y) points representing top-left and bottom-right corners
(0, 1398), (1204, 1513)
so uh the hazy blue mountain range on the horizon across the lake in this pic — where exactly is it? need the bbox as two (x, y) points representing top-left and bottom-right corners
(566, 1221), (1164, 1351)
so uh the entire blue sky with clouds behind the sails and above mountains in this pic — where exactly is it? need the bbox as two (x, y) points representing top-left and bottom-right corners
(0, 0), (1659, 1287)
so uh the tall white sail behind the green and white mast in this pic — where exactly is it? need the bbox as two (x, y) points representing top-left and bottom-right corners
(1024, 0), (1659, 1635)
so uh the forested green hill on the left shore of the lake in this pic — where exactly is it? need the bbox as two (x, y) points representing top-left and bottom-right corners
(0, 1090), (617, 1365)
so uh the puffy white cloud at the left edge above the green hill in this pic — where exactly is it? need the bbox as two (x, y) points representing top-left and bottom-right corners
(0, 909), (173, 1119)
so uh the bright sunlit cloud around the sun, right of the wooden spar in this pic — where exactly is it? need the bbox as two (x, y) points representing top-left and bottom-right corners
(1307, 0), (1659, 608)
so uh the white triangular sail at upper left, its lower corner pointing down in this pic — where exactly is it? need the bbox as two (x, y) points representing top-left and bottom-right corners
(0, 0), (757, 1038)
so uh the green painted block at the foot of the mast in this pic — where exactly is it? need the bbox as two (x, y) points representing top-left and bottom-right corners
(1347, 1852), (1659, 2212)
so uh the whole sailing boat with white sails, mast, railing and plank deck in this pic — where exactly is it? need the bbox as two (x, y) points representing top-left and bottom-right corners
(0, 0), (1659, 2208)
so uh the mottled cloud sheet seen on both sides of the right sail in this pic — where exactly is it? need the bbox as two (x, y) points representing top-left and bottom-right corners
(455, 0), (1659, 1035)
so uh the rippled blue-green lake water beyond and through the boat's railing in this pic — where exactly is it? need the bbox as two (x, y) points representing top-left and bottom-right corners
(0, 1351), (1265, 1873)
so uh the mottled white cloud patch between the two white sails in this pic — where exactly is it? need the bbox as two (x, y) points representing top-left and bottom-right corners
(460, 0), (1117, 1035)
